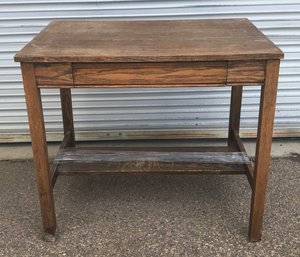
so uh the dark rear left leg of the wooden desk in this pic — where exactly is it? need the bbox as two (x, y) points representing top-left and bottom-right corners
(60, 88), (75, 147)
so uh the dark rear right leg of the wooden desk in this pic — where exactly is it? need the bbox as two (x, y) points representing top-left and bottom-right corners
(228, 86), (243, 146)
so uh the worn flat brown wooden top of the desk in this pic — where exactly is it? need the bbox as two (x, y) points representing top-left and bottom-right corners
(15, 19), (283, 62)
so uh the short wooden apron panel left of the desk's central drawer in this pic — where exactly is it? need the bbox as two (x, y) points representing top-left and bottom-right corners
(34, 63), (73, 85)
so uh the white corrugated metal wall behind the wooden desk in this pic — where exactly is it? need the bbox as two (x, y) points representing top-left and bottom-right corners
(0, 0), (300, 141)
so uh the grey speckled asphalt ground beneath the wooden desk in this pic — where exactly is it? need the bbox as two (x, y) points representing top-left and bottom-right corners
(0, 140), (300, 257)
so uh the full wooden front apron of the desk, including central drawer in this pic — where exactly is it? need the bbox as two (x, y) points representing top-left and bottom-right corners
(35, 60), (266, 88)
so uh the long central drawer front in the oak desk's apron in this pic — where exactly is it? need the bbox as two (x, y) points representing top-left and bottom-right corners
(73, 62), (227, 86)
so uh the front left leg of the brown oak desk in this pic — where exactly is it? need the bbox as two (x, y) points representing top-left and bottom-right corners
(21, 63), (56, 235)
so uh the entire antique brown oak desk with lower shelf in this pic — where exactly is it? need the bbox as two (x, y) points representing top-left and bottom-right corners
(15, 19), (283, 241)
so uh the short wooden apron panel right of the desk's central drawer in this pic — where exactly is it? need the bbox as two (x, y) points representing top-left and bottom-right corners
(227, 61), (266, 85)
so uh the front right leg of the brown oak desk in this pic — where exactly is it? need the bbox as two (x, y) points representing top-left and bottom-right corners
(249, 60), (280, 242)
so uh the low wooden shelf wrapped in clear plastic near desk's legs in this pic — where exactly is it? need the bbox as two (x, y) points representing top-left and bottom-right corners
(54, 147), (251, 175)
